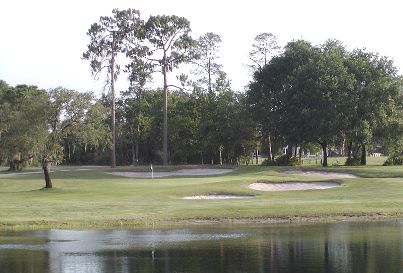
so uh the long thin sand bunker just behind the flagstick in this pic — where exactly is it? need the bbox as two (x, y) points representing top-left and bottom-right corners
(109, 169), (234, 178)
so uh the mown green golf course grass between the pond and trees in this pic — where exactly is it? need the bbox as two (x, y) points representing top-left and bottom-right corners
(0, 162), (403, 229)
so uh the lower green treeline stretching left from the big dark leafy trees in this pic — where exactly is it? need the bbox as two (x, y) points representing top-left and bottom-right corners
(0, 77), (257, 169)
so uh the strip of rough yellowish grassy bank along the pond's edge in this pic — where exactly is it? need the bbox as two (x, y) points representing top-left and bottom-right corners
(0, 213), (403, 232)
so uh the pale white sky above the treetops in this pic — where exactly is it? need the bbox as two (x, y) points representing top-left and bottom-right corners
(0, 0), (403, 93)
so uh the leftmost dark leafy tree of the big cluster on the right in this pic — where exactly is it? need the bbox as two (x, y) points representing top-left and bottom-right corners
(247, 41), (314, 160)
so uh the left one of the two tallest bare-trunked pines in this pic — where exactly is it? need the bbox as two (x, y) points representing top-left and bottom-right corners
(83, 9), (142, 168)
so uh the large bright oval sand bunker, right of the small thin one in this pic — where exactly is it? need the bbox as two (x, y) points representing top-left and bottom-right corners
(249, 182), (340, 191)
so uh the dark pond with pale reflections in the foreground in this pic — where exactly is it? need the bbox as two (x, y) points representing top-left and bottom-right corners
(0, 220), (403, 273)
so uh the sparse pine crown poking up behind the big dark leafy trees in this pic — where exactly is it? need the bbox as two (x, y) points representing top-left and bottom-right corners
(249, 32), (280, 71)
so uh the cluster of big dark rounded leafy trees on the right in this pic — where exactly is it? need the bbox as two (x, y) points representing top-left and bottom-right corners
(248, 40), (403, 166)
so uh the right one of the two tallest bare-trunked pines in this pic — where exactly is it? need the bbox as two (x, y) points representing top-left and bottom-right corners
(145, 15), (194, 165)
